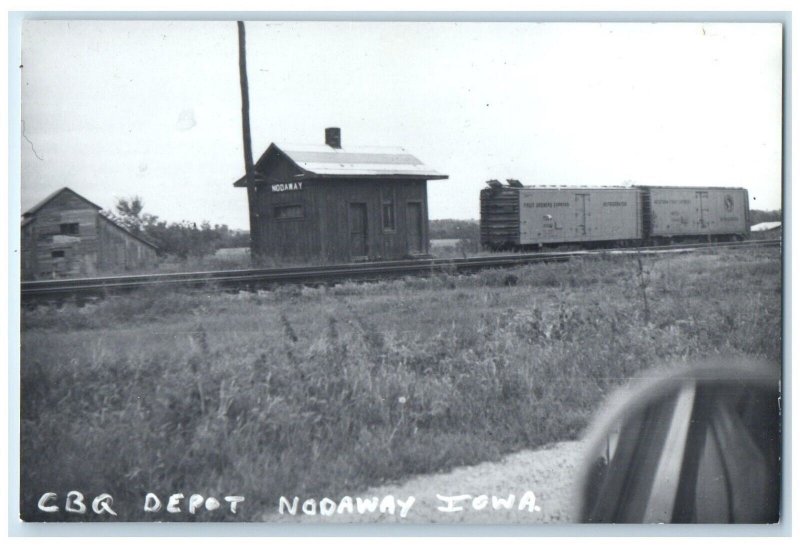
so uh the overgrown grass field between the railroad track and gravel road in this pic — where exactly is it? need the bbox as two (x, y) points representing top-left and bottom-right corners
(21, 246), (781, 520)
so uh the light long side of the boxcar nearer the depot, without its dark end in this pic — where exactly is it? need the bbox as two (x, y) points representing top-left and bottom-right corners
(519, 187), (642, 245)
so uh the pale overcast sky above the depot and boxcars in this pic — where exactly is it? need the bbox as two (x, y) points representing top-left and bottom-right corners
(22, 21), (782, 229)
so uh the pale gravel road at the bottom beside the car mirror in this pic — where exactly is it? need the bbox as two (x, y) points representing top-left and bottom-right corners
(264, 441), (582, 524)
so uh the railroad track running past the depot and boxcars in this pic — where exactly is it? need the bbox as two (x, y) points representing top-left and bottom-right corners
(21, 240), (781, 304)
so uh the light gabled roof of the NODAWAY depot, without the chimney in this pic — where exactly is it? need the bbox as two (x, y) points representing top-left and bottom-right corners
(233, 143), (448, 187)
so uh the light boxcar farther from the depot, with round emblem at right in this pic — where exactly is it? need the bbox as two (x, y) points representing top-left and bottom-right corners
(643, 187), (749, 237)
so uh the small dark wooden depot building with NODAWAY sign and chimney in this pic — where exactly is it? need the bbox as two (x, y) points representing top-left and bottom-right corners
(234, 128), (447, 263)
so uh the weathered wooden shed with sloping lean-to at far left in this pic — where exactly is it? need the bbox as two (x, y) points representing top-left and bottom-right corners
(22, 187), (157, 280)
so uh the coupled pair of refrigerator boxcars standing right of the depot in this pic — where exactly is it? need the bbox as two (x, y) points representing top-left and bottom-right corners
(480, 181), (749, 249)
